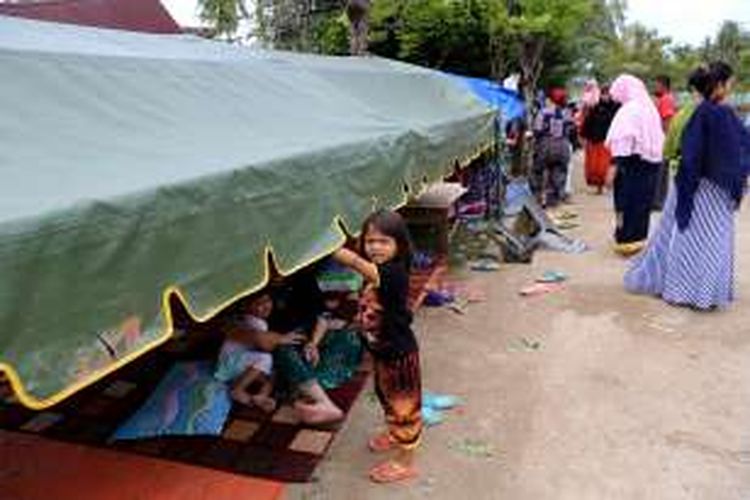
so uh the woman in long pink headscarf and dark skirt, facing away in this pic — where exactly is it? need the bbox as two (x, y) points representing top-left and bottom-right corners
(605, 75), (664, 255)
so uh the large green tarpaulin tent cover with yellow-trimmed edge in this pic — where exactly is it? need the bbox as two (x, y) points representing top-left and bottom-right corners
(0, 17), (493, 408)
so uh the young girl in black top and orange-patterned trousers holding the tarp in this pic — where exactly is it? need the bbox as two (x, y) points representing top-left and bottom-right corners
(333, 210), (422, 483)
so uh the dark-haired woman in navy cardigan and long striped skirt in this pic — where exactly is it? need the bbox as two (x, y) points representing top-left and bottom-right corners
(625, 63), (750, 309)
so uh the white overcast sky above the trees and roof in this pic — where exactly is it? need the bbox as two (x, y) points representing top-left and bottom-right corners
(162, 0), (750, 45)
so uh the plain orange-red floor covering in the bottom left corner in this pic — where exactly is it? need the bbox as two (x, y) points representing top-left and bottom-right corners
(0, 430), (284, 500)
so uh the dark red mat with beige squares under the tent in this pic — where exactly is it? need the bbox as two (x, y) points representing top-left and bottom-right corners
(0, 352), (368, 482)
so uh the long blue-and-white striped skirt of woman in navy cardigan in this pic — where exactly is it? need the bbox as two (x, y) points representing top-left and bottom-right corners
(625, 179), (735, 309)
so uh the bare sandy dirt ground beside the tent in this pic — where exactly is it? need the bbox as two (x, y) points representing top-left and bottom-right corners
(287, 159), (750, 500)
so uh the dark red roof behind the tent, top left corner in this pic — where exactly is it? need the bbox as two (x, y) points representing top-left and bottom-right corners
(0, 0), (180, 33)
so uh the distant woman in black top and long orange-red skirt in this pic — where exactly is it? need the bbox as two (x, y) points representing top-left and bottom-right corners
(581, 81), (618, 194)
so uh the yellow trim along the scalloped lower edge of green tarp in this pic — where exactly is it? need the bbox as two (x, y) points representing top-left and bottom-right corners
(0, 141), (494, 410)
